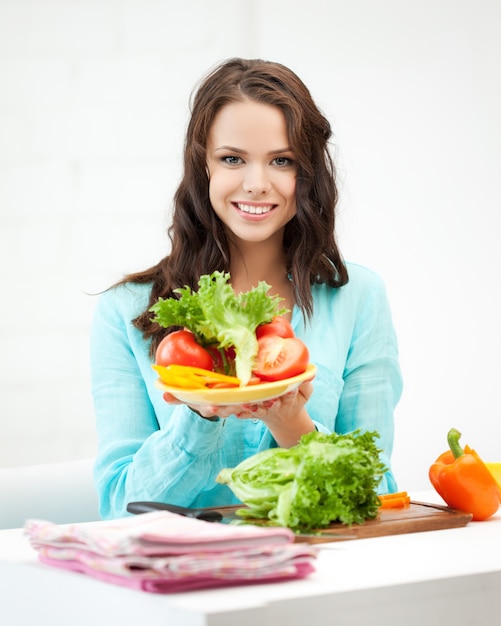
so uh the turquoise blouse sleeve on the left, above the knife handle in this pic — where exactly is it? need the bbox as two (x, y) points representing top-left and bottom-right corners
(91, 287), (229, 518)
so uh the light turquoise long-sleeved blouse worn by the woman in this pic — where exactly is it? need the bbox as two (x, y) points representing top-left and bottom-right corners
(91, 263), (402, 519)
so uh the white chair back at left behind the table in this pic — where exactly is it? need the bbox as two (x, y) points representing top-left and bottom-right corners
(0, 458), (99, 529)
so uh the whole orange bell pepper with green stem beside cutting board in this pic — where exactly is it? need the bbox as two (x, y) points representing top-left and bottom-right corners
(429, 428), (501, 521)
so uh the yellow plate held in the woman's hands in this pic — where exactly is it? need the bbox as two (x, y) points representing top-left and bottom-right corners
(156, 363), (317, 406)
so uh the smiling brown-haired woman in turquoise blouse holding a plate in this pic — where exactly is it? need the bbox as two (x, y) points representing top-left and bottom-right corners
(91, 59), (401, 518)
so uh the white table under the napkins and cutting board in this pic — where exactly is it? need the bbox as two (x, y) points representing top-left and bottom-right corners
(0, 492), (501, 626)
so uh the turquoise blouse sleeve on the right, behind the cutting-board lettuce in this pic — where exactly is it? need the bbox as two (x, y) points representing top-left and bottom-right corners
(336, 277), (402, 493)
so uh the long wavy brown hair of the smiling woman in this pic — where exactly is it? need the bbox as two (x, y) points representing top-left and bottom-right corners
(119, 58), (348, 352)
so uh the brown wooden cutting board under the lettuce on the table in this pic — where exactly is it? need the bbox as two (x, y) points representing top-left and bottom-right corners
(210, 501), (472, 543)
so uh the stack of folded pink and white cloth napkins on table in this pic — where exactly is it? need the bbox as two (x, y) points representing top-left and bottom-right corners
(25, 511), (316, 593)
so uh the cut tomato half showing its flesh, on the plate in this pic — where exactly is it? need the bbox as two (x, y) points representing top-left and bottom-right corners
(253, 335), (310, 381)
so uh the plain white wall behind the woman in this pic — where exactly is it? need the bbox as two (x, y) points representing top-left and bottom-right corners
(0, 0), (501, 489)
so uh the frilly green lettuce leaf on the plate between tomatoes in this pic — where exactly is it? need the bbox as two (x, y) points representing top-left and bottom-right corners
(150, 272), (287, 385)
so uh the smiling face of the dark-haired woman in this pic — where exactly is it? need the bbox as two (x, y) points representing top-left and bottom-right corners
(207, 100), (296, 242)
